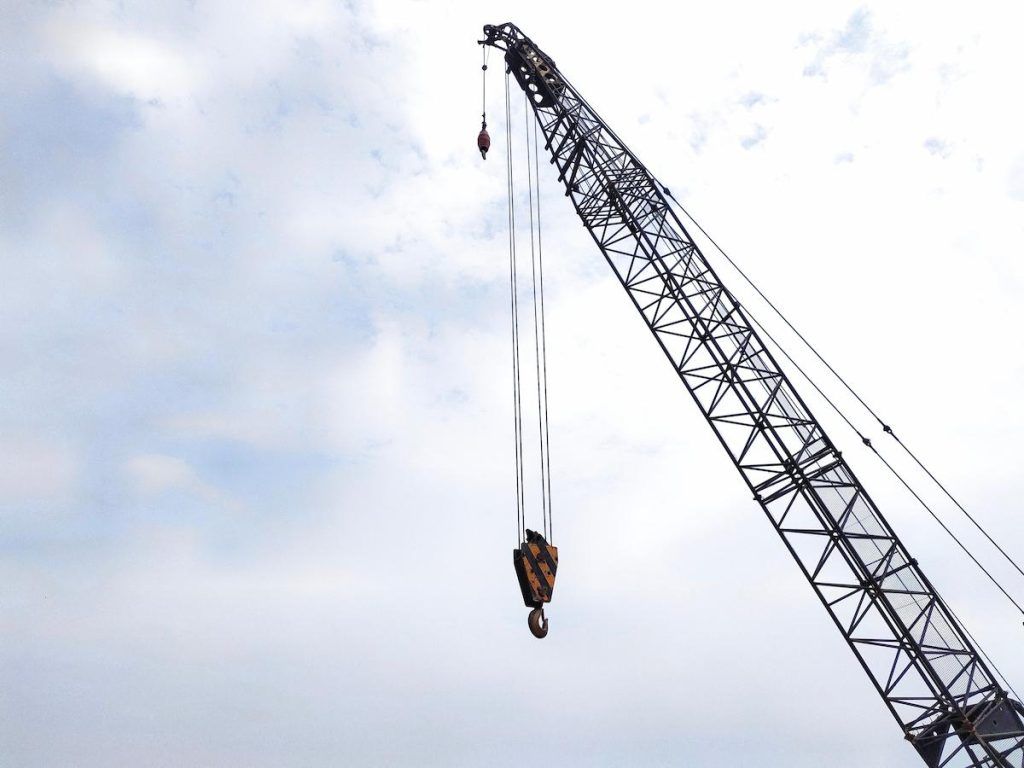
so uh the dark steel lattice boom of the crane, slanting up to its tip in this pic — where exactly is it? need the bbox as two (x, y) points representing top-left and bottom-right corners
(479, 24), (1024, 768)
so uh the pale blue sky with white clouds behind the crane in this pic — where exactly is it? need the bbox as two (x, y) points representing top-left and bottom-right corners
(0, 0), (1024, 768)
